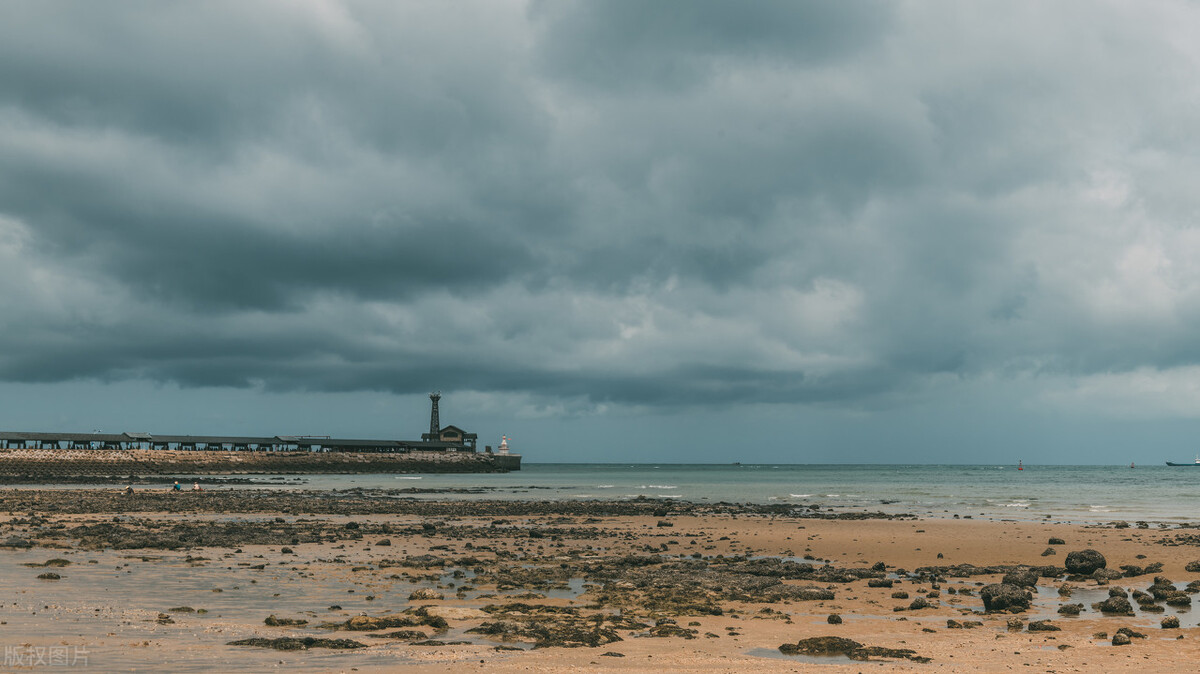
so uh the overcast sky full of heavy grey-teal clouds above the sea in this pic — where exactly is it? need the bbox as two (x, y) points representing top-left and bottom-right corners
(0, 0), (1200, 463)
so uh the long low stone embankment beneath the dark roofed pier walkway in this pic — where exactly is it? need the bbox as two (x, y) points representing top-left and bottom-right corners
(0, 450), (520, 480)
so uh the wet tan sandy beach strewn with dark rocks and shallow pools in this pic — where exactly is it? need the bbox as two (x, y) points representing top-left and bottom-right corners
(0, 489), (1200, 672)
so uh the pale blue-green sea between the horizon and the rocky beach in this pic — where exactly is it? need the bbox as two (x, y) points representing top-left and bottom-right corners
(177, 463), (1200, 524)
